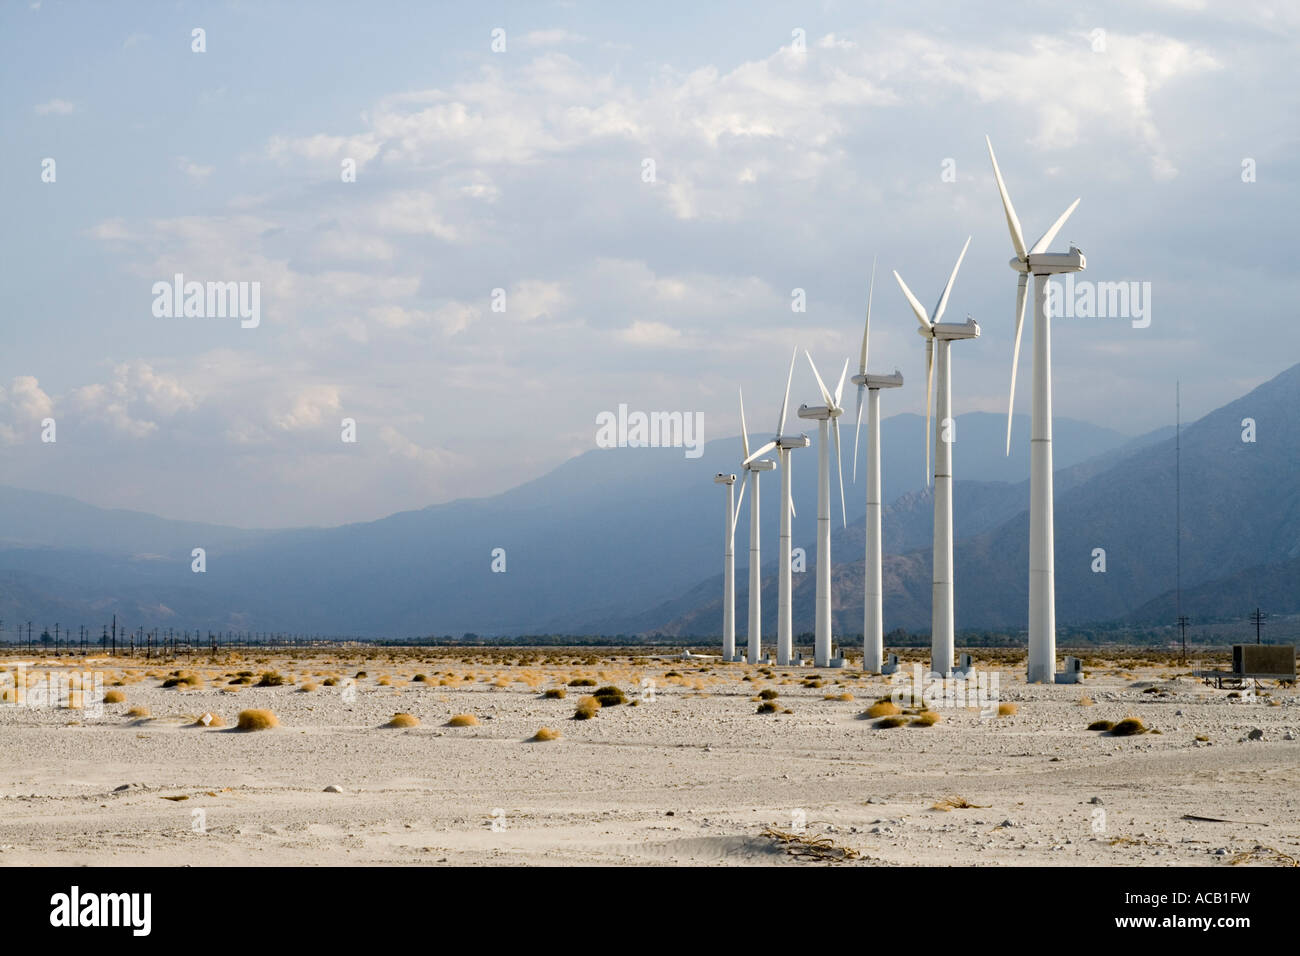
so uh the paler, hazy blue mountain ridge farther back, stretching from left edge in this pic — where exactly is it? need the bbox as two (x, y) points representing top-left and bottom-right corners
(0, 412), (1125, 636)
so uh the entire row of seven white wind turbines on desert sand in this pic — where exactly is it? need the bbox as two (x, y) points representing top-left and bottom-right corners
(714, 137), (1087, 683)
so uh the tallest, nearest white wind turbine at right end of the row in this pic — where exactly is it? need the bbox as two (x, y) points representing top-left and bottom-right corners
(984, 137), (1088, 684)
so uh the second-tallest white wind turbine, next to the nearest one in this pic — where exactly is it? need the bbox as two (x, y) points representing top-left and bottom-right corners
(894, 238), (979, 678)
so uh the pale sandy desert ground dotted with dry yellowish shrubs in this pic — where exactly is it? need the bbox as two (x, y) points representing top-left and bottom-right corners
(0, 649), (1300, 866)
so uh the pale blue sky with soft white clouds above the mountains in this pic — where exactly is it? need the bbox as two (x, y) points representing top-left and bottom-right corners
(0, 0), (1300, 527)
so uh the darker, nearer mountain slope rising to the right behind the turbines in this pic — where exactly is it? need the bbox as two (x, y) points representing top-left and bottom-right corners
(646, 365), (1300, 635)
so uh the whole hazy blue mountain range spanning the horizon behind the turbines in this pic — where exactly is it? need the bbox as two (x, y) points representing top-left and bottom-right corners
(0, 365), (1300, 637)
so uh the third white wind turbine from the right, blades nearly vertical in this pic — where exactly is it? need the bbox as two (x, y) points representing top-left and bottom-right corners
(849, 260), (902, 674)
